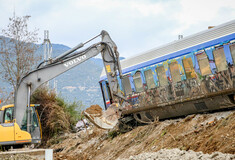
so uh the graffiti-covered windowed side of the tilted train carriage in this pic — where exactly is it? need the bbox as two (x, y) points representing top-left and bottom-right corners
(124, 42), (235, 112)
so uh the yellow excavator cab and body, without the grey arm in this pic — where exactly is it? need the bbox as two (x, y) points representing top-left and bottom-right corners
(0, 104), (41, 146)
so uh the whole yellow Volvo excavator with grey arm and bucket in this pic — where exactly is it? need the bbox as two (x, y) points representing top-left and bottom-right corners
(0, 31), (123, 146)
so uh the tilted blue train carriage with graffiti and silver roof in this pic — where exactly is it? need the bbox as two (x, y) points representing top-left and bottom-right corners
(99, 20), (235, 123)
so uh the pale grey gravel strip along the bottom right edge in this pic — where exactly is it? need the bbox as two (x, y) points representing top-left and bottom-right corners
(118, 148), (235, 160)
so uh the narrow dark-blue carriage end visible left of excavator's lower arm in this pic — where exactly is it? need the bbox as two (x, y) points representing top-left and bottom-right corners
(100, 81), (112, 109)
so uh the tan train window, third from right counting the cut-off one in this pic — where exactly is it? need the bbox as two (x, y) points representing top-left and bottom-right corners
(197, 52), (211, 76)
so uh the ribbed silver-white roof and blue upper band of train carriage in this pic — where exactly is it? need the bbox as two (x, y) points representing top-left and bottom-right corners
(100, 20), (235, 80)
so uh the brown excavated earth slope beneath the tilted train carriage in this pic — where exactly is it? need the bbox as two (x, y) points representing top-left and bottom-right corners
(50, 110), (235, 160)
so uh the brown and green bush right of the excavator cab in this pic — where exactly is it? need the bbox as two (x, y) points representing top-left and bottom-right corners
(31, 87), (83, 146)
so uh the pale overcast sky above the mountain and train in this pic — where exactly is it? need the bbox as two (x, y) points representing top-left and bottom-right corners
(0, 0), (235, 57)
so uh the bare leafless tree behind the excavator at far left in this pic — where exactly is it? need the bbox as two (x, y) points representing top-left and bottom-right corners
(0, 15), (40, 100)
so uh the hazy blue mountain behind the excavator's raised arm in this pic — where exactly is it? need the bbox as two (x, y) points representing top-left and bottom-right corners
(37, 44), (104, 107)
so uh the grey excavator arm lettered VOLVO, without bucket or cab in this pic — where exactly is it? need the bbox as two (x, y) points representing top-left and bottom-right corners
(14, 31), (122, 135)
